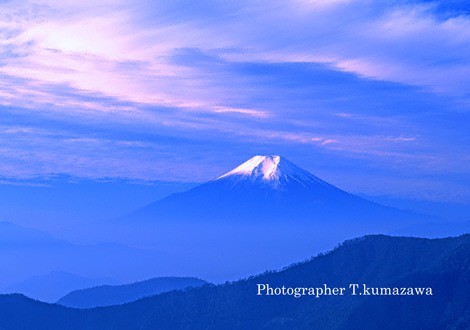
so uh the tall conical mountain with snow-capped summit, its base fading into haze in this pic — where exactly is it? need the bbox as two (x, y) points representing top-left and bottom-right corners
(105, 155), (439, 282)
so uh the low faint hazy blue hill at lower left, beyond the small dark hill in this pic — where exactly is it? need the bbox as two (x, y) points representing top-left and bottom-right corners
(2, 271), (118, 302)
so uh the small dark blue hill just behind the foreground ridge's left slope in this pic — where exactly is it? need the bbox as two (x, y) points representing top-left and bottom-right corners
(57, 277), (208, 308)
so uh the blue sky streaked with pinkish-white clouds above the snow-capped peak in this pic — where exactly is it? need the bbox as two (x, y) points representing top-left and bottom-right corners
(0, 0), (470, 204)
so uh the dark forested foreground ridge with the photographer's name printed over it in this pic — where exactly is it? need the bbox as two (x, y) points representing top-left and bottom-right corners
(0, 235), (470, 330)
